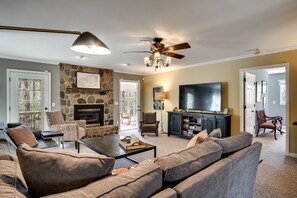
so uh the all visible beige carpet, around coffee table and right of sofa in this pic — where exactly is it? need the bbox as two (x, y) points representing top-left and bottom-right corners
(65, 130), (297, 198)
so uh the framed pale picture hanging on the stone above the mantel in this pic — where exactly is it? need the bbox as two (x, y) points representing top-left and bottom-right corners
(76, 72), (100, 89)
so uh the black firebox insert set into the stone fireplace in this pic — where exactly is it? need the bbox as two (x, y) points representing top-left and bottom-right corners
(74, 104), (104, 127)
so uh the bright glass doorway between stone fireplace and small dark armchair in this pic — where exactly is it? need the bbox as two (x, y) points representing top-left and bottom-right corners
(119, 79), (140, 131)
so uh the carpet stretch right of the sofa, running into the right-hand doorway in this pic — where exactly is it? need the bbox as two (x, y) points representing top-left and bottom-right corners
(254, 133), (297, 198)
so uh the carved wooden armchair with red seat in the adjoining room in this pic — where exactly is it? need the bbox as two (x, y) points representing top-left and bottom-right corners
(256, 110), (284, 140)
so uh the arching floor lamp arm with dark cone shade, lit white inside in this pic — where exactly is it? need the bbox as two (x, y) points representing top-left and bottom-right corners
(0, 26), (110, 55)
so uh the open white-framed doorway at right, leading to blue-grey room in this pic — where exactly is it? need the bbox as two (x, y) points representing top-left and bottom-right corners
(240, 63), (289, 154)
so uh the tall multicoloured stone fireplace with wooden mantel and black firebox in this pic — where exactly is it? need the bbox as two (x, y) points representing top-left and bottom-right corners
(60, 63), (118, 138)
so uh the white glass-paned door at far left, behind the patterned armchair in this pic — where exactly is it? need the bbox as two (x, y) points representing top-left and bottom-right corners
(7, 69), (51, 131)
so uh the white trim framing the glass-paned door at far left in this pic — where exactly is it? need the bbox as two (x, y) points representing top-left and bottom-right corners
(6, 69), (52, 130)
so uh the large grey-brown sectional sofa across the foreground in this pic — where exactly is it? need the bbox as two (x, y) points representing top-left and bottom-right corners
(0, 131), (262, 198)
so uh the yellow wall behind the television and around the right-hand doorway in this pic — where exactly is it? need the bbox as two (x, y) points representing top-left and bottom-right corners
(144, 50), (297, 153)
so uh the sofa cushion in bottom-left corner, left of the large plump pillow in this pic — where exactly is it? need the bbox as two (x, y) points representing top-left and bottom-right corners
(0, 160), (30, 198)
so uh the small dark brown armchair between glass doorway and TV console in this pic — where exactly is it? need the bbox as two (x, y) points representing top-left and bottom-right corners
(139, 112), (160, 136)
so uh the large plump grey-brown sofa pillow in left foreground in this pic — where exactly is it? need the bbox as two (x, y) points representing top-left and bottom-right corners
(17, 145), (115, 197)
